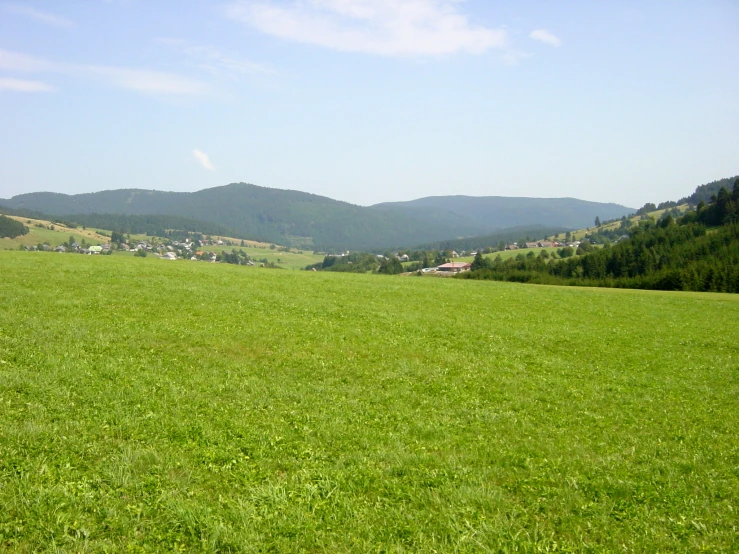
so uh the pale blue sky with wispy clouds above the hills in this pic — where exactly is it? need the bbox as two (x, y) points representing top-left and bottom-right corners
(0, 0), (739, 207)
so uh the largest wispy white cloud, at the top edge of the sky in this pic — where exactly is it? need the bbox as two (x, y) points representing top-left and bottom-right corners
(226, 0), (508, 56)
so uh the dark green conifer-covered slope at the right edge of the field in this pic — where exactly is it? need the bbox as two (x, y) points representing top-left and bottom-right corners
(464, 179), (739, 293)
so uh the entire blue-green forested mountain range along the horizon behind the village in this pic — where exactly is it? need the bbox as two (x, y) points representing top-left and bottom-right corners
(0, 183), (635, 250)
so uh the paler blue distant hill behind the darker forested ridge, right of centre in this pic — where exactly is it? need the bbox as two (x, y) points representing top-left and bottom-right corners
(372, 196), (635, 234)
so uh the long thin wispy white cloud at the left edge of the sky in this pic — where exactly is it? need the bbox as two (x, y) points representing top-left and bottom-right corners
(0, 50), (211, 96)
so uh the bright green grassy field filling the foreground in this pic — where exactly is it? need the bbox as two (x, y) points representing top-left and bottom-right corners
(0, 252), (739, 552)
